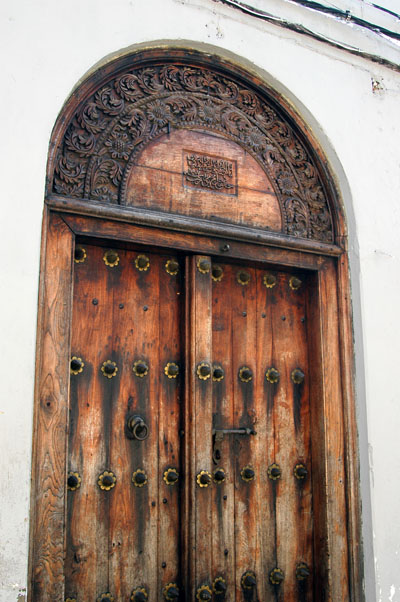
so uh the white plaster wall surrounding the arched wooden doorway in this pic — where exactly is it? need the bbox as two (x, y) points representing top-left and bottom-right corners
(0, 0), (400, 602)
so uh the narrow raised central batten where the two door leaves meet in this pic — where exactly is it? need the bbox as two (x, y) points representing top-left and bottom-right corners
(185, 256), (212, 600)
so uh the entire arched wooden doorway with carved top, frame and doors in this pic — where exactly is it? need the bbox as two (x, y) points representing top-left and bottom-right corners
(31, 49), (359, 602)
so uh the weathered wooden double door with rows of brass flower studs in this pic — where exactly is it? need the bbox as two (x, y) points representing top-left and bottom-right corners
(65, 243), (318, 602)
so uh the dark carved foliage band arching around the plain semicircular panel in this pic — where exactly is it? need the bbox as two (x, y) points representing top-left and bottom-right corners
(52, 62), (333, 242)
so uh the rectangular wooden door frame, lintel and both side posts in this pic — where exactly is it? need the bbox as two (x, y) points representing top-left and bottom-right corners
(28, 203), (364, 602)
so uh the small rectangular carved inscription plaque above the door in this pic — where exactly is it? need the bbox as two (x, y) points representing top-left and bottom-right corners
(183, 151), (237, 195)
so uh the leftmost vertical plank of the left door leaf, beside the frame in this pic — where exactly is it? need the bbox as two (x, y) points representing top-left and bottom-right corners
(65, 245), (112, 599)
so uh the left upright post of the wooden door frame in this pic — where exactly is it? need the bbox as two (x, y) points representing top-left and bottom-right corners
(29, 213), (74, 602)
